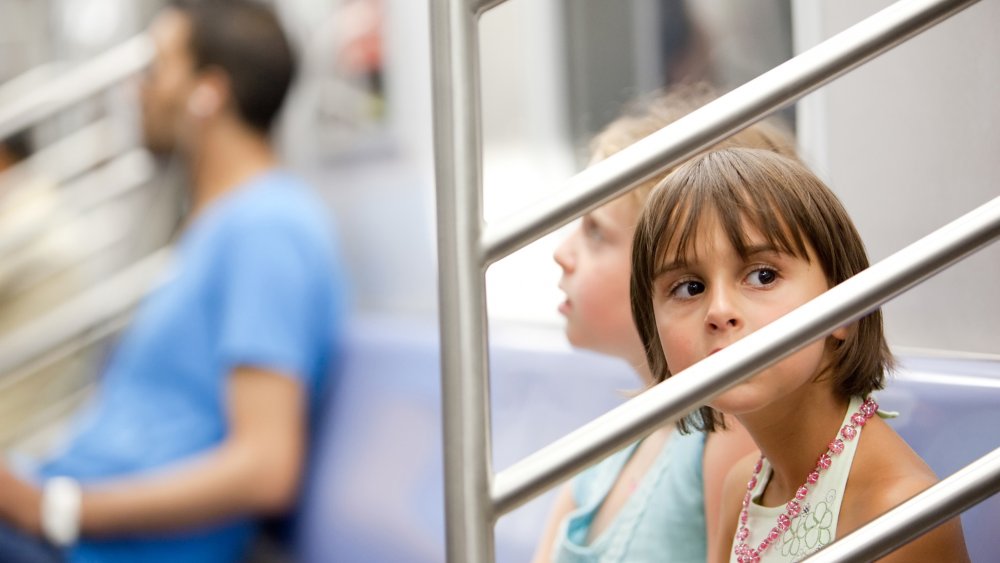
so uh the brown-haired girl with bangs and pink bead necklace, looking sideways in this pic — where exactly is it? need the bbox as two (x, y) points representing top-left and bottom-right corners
(632, 149), (968, 562)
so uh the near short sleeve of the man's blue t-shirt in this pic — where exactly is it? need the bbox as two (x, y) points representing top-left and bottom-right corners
(219, 220), (320, 379)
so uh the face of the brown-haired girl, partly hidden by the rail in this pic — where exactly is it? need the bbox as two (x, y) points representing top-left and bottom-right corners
(653, 213), (846, 415)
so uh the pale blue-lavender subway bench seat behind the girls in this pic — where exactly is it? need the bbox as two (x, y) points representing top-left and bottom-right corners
(294, 318), (1000, 563)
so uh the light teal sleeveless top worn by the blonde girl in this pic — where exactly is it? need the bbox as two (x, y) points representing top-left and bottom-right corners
(552, 430), (708, 563)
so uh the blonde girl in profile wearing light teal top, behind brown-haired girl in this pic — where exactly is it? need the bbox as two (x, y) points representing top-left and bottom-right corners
(535, 86), (794, 563)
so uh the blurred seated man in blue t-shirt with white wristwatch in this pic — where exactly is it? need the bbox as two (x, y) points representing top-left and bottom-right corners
(0, 0), (343, 562)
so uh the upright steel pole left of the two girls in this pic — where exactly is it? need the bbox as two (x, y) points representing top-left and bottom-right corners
(430, 0), (495, 563)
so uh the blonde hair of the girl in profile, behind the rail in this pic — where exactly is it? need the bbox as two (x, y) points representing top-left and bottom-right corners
(590, 82), (798, 214)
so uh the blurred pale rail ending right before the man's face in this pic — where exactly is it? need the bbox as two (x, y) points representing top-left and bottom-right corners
(0, 33), (155, 138)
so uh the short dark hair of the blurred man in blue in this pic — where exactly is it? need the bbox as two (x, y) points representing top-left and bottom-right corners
(170, 0), (295, 134)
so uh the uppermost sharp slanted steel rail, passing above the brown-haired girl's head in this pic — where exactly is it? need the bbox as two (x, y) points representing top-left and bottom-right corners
(482, 0), (977, 265)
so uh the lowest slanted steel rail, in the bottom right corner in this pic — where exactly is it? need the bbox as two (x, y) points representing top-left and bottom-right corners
(805, 448), (1000, 563)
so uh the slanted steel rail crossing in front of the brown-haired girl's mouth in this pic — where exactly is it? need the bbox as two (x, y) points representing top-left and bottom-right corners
(492, 197), (1000, 514)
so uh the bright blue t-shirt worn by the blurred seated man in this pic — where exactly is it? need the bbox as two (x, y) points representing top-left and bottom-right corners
(41, 171), (344, 563)
